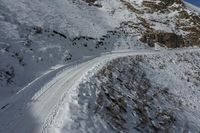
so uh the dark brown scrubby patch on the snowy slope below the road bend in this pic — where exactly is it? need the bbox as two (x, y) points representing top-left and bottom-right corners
(96, 56), (176, 132)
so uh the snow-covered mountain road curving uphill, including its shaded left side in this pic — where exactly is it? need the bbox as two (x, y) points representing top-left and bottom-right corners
(0, 49), (198, 133)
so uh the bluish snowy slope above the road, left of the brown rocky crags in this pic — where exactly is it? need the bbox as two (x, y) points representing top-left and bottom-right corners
(0, 0), (145, 99)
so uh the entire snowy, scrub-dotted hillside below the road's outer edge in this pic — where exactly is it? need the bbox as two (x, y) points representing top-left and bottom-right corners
(43, 50), (200, 133)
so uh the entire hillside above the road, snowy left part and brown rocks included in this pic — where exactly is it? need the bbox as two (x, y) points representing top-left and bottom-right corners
(0, 0), (200, 96)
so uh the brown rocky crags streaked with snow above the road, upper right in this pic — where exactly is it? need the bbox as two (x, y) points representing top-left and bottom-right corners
(140, 0), (200, 48)
